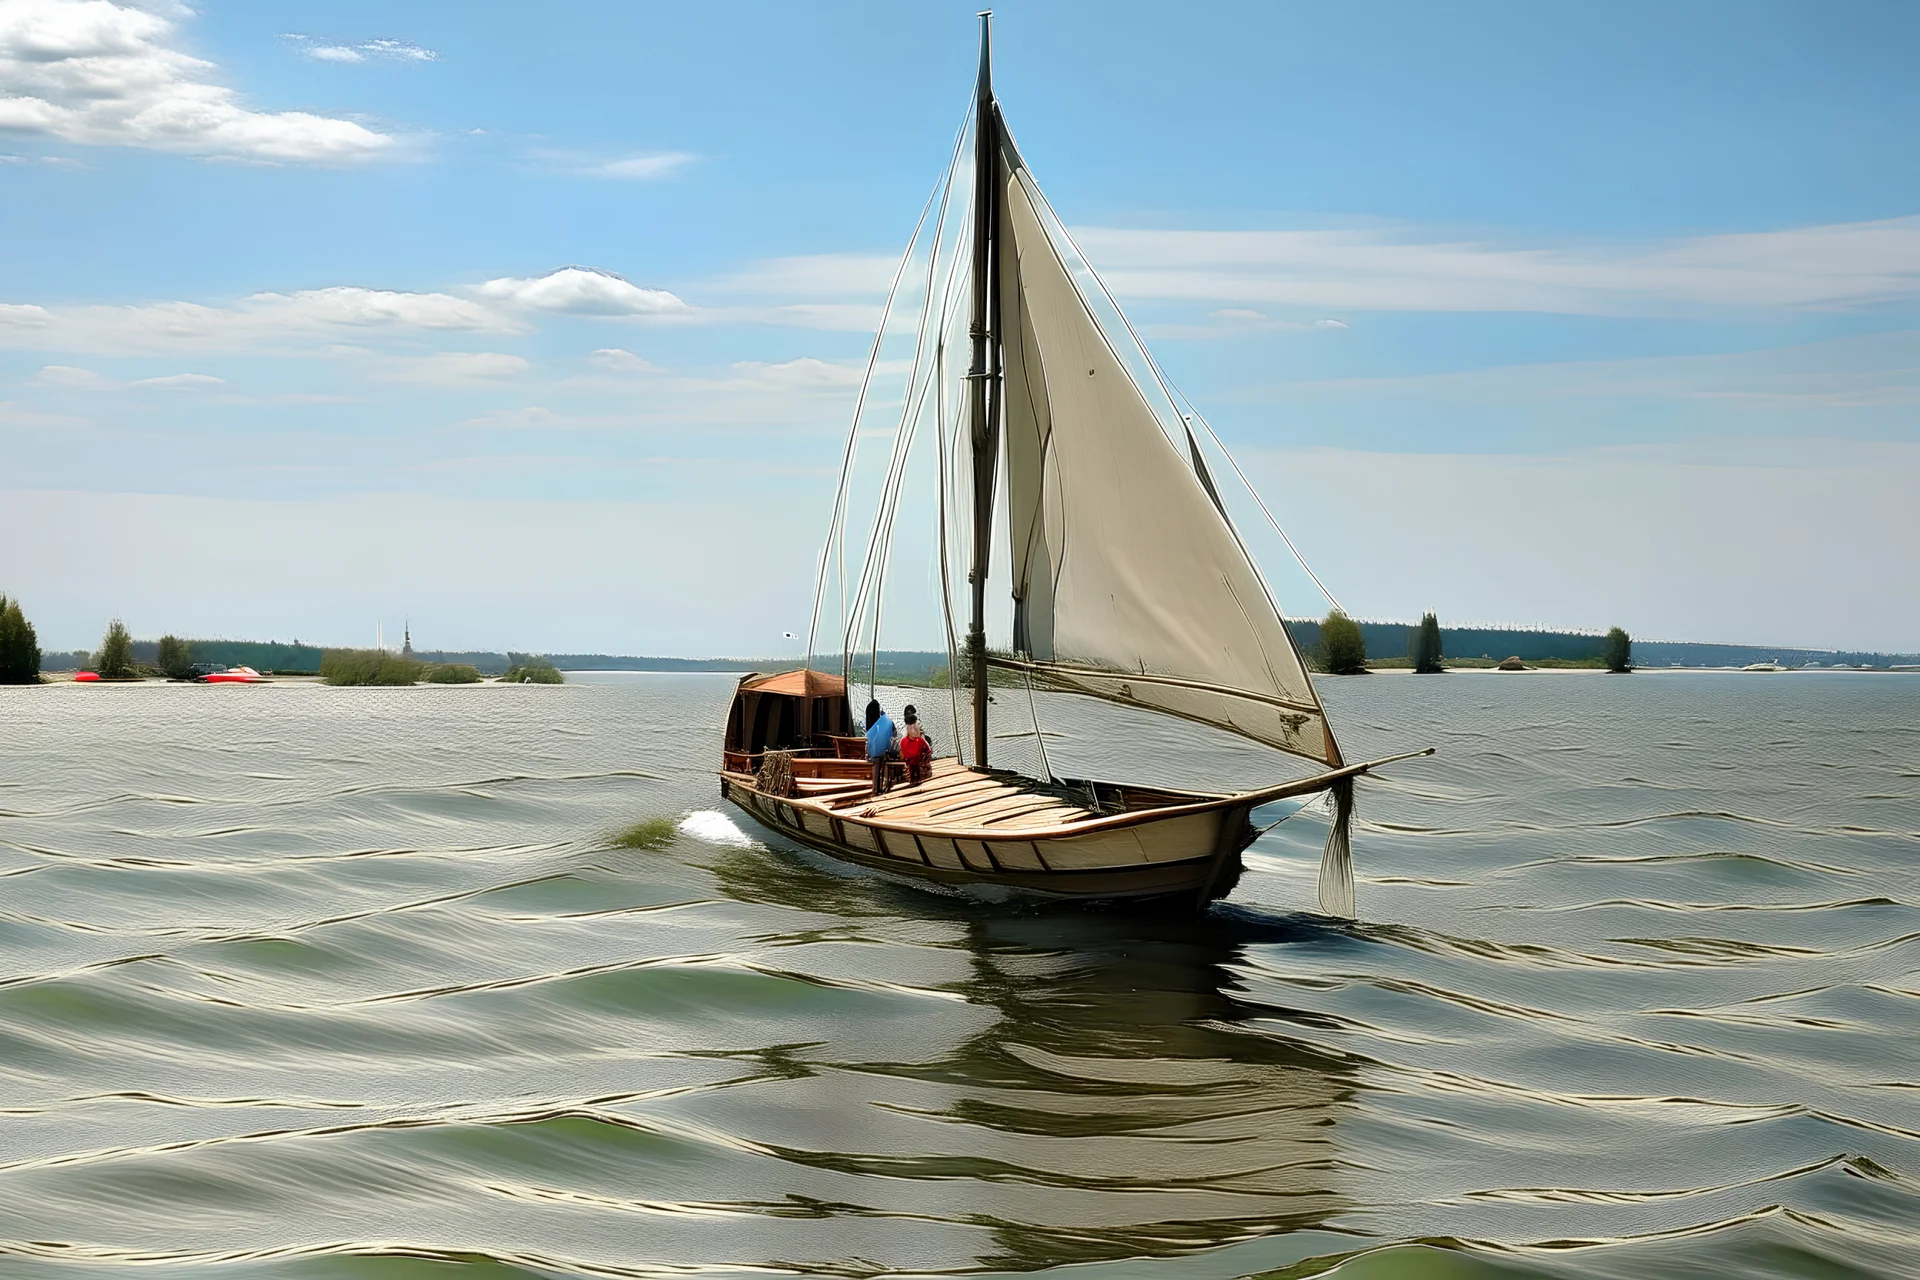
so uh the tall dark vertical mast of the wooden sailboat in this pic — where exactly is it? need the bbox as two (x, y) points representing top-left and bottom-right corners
(966, 10), (1000, 768)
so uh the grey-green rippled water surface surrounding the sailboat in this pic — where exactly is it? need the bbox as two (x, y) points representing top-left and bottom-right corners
(0, 674), (1920, 1280)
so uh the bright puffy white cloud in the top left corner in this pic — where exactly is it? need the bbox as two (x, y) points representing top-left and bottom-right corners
(0, 0), (397, 163)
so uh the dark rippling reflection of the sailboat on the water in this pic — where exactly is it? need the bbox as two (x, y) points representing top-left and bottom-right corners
(714, 852), (1357, 1270)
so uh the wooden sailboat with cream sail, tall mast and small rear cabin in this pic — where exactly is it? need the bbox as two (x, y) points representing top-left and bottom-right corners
(720, 17), (1427, 915)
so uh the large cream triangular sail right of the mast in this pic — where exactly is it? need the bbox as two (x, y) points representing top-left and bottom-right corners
(991, 144), (1340, 766)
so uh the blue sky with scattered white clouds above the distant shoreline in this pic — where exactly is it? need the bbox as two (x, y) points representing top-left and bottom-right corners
(0, 0), (1920, 652)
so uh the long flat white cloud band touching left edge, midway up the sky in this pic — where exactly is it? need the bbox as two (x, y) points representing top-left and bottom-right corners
(0, 286), (526, 355)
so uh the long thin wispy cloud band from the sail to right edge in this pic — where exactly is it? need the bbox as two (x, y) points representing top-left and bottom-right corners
(1075, 217), (1920, 315)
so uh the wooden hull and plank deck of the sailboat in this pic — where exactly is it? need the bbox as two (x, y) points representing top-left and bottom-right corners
(720, 760), (1254, 906)
